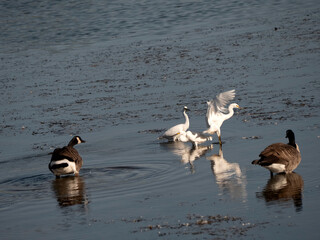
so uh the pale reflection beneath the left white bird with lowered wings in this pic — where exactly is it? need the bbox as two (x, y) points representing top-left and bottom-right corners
(163, 142), (213, 173)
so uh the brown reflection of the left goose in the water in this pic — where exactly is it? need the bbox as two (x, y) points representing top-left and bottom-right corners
(52, 176), (88, 207)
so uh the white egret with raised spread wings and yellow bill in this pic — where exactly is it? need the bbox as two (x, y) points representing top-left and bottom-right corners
(203, 90), (240, 146)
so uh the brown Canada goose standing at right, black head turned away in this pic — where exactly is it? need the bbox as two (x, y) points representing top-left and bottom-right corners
(252, 130), (301, 175)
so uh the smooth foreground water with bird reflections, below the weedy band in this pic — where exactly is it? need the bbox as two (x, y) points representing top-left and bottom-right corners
(0, 119), (319, 239)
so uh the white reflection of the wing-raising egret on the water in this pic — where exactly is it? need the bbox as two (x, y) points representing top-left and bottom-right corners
(207, 146), (247, 201)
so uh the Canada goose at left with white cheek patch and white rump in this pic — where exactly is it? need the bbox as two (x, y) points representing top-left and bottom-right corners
(49, 136), (85, 178)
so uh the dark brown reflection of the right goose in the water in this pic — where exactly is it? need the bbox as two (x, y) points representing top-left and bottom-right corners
(257, 172), (304, 212)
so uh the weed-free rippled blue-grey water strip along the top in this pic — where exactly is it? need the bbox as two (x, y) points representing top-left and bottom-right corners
(0, 0), (319, 51)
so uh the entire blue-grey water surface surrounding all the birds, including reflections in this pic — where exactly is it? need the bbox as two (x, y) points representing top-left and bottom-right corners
(0, 1), (320, 239)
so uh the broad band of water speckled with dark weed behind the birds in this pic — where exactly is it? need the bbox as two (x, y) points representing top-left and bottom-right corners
(1, 6), (319, 142)
